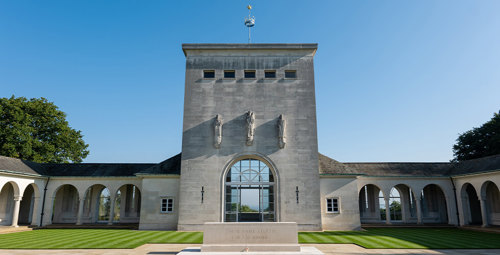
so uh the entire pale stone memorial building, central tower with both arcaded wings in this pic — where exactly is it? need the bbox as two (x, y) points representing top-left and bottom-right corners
(0, 44), (500, 230)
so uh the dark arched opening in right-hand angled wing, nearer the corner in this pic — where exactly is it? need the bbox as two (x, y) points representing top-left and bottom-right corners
(461, 183), (483, 225)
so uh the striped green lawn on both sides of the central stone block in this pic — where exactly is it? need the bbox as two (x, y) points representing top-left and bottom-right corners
(0, 228), (500, 249)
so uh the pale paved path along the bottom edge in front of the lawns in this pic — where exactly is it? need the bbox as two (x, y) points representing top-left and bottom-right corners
(0, 244), (500, 255)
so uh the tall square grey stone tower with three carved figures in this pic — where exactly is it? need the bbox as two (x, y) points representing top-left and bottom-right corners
(178, 44), (321, 230)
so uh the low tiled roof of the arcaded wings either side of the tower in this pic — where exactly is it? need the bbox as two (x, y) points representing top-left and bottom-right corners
(0, 153), (500, 177)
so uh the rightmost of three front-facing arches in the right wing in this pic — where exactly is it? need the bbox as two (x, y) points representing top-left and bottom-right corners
(420, 183), (449, 223)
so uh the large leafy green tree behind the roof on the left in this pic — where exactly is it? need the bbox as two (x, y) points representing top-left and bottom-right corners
(0, 96), (89, 163)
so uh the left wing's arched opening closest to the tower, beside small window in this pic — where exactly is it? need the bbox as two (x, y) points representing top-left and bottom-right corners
(113, 184), (142, 223)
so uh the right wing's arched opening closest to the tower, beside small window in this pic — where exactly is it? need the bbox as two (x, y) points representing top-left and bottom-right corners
(358, 183), (386, 223)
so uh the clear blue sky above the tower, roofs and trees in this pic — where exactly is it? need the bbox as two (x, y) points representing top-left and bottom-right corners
(0, 0), (500, 162)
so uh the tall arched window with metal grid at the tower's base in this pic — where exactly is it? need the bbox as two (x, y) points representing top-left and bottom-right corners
(224, 158), (276, 222)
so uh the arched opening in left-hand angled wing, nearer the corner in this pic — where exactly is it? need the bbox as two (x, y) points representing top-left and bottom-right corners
(18, 183), (40, 225)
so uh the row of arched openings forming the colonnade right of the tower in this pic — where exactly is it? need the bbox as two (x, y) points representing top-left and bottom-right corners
(359, 180), (500, 227)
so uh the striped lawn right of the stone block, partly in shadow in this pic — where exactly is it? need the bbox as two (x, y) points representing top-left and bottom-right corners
(299, 228), (500, 249)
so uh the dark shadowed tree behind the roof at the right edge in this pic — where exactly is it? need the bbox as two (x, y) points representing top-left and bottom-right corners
(453, 111), (500, 161)
